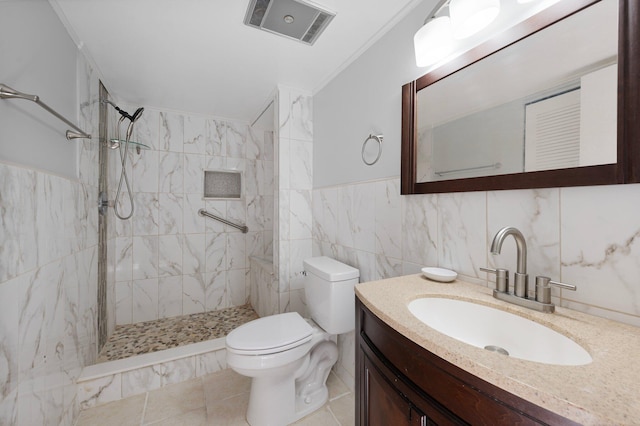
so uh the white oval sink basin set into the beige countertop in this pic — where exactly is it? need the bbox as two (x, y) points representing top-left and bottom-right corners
(408, 297), (592, 365)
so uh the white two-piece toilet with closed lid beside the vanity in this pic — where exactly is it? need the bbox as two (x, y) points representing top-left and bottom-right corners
(226, 256), (360, 426)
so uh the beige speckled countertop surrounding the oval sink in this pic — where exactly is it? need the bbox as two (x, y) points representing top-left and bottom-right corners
(356, 275), (640, 425)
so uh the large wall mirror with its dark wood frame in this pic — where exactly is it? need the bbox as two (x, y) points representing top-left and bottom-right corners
(401, 0), (640, 194)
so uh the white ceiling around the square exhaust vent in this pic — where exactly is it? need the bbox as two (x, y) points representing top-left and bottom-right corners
(49, 0), (422, 121)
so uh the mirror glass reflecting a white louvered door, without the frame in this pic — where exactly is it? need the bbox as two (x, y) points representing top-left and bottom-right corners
(415, 0), (618, 182)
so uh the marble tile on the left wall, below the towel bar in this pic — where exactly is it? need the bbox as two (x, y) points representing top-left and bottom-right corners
(0, 55), (98, 425)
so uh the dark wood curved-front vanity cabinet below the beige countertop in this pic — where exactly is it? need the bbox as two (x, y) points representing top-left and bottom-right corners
(356, 298), (577, 426)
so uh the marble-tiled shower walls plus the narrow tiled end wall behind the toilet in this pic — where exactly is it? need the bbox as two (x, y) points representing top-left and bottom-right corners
(99, 88), (312, 330)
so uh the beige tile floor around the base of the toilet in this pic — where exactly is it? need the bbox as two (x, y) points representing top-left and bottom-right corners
(76, 369), (355, 426)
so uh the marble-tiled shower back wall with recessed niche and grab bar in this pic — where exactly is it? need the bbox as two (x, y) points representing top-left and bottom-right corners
(109, 105), (274, 324)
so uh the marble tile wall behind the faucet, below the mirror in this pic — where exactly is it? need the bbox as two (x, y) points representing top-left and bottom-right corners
(313, 179), (640, 384)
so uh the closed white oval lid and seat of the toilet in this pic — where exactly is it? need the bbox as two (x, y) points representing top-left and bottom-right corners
(226, 312), (313, 355)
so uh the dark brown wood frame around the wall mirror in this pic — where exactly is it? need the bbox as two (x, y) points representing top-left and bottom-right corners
(401, 0), (640, 195)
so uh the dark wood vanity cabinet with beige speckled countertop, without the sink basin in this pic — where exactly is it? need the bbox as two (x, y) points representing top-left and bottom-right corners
(356, 275), (640, 425)
